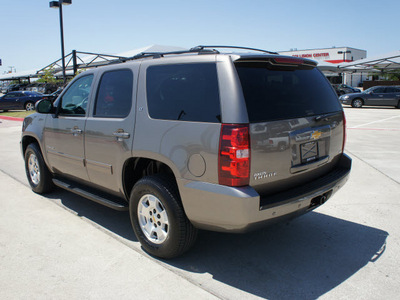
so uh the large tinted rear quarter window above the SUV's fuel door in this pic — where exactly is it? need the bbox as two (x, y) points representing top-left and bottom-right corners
(147, 64), (221, 122)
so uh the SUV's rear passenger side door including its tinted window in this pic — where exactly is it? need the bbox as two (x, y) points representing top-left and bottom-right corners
(85, 67), (137, 194)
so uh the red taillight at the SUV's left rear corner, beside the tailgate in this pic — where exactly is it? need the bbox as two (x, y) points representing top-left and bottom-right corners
(218, 124), (250, 186)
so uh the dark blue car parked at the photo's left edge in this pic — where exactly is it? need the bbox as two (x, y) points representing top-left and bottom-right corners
(0, 91), (43, 111)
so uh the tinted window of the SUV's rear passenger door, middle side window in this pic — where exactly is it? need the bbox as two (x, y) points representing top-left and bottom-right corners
(93, 70), (133, 118)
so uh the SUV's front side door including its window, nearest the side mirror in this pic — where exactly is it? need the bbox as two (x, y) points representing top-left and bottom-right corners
(43, 74), (93, 181)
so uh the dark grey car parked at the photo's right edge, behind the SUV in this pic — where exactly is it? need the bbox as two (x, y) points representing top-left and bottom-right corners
(339, 86), (400, 108)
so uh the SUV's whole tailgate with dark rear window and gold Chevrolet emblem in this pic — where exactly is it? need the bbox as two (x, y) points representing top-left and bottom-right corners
(235, 58), (343, 195)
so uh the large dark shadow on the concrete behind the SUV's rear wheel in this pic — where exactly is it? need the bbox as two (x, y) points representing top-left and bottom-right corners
(165, 212), (388, 299)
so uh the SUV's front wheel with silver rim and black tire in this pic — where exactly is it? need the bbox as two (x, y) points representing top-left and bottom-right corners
(25, 143), (54, 194)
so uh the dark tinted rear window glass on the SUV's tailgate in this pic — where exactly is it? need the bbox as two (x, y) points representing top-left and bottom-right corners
(236, 63), (342, 123)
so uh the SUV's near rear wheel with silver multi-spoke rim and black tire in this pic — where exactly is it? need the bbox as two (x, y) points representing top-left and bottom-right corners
(129, 174), (197, 258)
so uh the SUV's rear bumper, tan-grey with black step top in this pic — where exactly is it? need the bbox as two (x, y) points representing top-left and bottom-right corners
(178, 155), (351, 232)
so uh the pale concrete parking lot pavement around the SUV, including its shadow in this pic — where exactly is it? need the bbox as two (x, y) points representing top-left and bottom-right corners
(0, 108), (400, 299)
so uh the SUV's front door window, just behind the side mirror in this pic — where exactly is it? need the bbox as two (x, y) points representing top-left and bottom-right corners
(60, 75), (93, 116)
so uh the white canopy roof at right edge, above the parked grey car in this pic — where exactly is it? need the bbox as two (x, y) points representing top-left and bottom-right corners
(338, 51), (400, 72)
